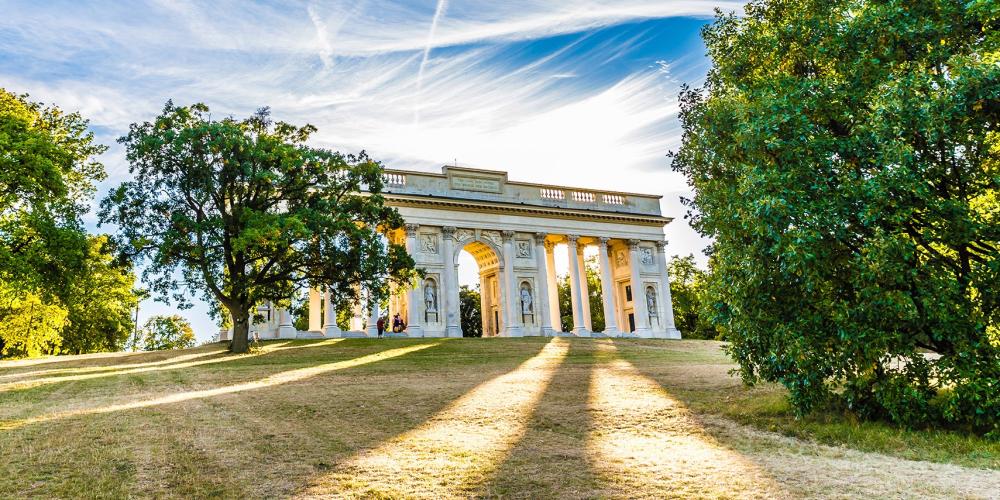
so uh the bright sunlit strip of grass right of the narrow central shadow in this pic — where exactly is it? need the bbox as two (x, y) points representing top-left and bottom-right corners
(587, 340), (788, 497)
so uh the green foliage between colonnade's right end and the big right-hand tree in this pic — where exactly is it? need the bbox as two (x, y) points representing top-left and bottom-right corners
(667, 255), (719, 339)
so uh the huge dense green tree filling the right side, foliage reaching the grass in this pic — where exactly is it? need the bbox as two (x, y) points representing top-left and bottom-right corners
(673, 0), (1000, 435)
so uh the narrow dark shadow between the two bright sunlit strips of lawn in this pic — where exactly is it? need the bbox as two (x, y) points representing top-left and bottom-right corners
(476, 340), (597, 498)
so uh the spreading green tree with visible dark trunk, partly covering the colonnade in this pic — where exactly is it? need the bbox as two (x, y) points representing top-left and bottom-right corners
(101, 102), (422, 352)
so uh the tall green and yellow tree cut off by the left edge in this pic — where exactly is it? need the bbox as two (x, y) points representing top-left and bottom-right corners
(0, 89), (106, 356)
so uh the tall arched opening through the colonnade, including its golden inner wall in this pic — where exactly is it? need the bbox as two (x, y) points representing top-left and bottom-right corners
(456, 241), (504, 337)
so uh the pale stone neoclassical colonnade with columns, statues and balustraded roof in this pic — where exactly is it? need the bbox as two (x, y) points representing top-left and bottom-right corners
(223, 166), (681, 339)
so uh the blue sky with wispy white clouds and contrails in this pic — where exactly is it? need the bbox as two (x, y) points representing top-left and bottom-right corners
(0, 0), (741, 339)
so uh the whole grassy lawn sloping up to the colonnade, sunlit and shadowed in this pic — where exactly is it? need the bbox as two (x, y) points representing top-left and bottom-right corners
(0, 338), (1000, 498)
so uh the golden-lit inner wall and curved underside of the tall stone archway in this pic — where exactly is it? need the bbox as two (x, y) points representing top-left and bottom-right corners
(452, 235), (509, 337)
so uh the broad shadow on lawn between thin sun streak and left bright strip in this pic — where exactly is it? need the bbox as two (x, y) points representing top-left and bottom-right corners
(0, 339), (556, 497)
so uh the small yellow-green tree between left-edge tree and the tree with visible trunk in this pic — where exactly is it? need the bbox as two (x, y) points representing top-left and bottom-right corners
(61, 236), (138, 354)
